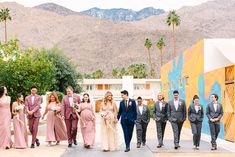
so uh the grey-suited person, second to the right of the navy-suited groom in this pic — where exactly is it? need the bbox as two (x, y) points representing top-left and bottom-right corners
(154, 93), (168, 148)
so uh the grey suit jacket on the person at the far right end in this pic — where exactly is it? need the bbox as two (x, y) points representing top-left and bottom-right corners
(206, 102), (224, 123)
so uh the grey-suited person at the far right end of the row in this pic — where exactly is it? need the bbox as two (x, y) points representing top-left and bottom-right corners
(206, 94), (224, 150)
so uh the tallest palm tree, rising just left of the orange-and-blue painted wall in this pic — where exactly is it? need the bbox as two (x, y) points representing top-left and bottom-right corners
(166, 10), (180, 57)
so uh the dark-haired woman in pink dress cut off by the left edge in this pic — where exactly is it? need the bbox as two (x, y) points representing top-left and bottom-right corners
(0, 87), (12, 149)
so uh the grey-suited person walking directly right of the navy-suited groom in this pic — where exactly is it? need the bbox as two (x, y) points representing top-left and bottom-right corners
(136, 97), (150, 148)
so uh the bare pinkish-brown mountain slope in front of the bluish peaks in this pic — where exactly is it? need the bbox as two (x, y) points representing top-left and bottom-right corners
(0, 0), (235, 78)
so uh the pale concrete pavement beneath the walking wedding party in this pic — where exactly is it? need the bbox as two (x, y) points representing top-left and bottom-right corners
(0, 114), (235, 157)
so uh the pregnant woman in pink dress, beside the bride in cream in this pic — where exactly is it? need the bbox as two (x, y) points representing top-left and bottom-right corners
(78, 93), (95, 149)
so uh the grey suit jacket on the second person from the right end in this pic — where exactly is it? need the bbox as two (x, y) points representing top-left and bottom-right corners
(188, 104), (204, 123)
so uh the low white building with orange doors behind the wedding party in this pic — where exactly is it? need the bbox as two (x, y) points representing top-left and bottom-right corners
(81, 76), (161, 101)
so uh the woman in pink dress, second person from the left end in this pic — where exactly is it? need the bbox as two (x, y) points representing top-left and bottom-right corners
(12, 94), (28, 149)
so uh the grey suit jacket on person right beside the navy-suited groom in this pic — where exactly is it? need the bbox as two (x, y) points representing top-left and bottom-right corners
(136, 104), (150, 123)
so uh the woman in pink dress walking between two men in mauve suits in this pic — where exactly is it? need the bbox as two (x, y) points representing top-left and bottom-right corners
(42, 92), (68, 146)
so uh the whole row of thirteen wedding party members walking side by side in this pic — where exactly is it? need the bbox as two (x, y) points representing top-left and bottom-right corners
(0, 86), (223, 152)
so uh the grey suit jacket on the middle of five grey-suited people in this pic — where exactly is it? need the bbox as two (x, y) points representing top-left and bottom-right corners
(167, 99), (187, 122)
